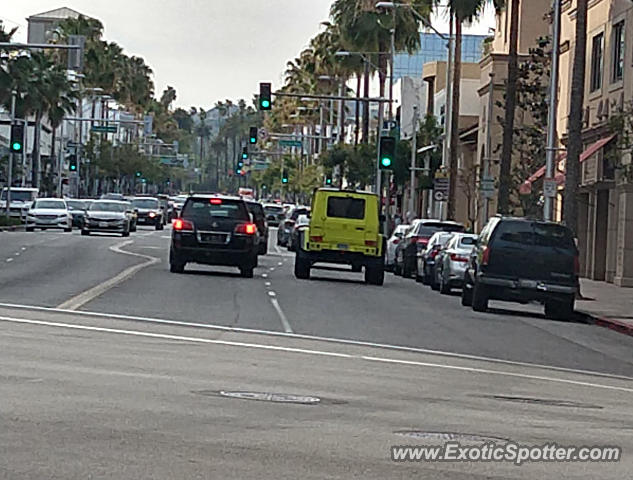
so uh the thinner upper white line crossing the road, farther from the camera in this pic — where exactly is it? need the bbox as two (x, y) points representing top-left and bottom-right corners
(0, 302), (633, 381)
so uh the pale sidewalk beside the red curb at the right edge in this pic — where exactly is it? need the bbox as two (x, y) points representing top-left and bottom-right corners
(576, 278), (633, 336)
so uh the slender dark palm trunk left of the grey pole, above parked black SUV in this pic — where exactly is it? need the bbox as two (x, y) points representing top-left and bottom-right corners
(497, 0), (520, 214)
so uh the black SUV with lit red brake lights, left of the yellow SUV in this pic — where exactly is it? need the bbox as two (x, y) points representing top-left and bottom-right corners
(169, 195), (259, 278)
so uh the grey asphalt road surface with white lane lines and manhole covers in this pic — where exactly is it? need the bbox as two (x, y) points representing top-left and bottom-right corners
(0, 227), (633, 479)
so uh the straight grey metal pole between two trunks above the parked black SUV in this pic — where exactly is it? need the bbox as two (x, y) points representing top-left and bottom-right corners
(543, 0), (561, 221)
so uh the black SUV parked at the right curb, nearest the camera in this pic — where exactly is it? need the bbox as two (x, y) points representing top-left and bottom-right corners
(462, 217), (578, 319)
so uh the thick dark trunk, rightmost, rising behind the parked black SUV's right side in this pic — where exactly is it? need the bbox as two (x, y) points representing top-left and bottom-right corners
(563, 0), (588, 237)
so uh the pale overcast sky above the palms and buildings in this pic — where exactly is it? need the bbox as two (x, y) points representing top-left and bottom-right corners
(0, 0), (494, 108)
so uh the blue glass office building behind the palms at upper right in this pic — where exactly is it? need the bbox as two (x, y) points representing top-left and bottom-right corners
(393, 32), (488, 81)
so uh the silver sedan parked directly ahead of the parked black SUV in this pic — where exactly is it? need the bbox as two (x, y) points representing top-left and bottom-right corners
(434, 233), (477, 294)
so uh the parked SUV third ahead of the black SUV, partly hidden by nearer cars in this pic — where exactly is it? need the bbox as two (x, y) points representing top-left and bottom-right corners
(393, 219), (465, 278)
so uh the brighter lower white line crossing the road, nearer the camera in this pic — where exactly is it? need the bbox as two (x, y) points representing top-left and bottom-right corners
(0, 316), (633, 393)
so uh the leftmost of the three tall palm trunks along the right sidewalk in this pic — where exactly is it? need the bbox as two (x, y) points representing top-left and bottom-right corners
(446, 16), (462, 220)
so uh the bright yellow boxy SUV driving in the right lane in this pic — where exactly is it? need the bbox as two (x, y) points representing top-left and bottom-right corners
(295, 188), (385, 285)
